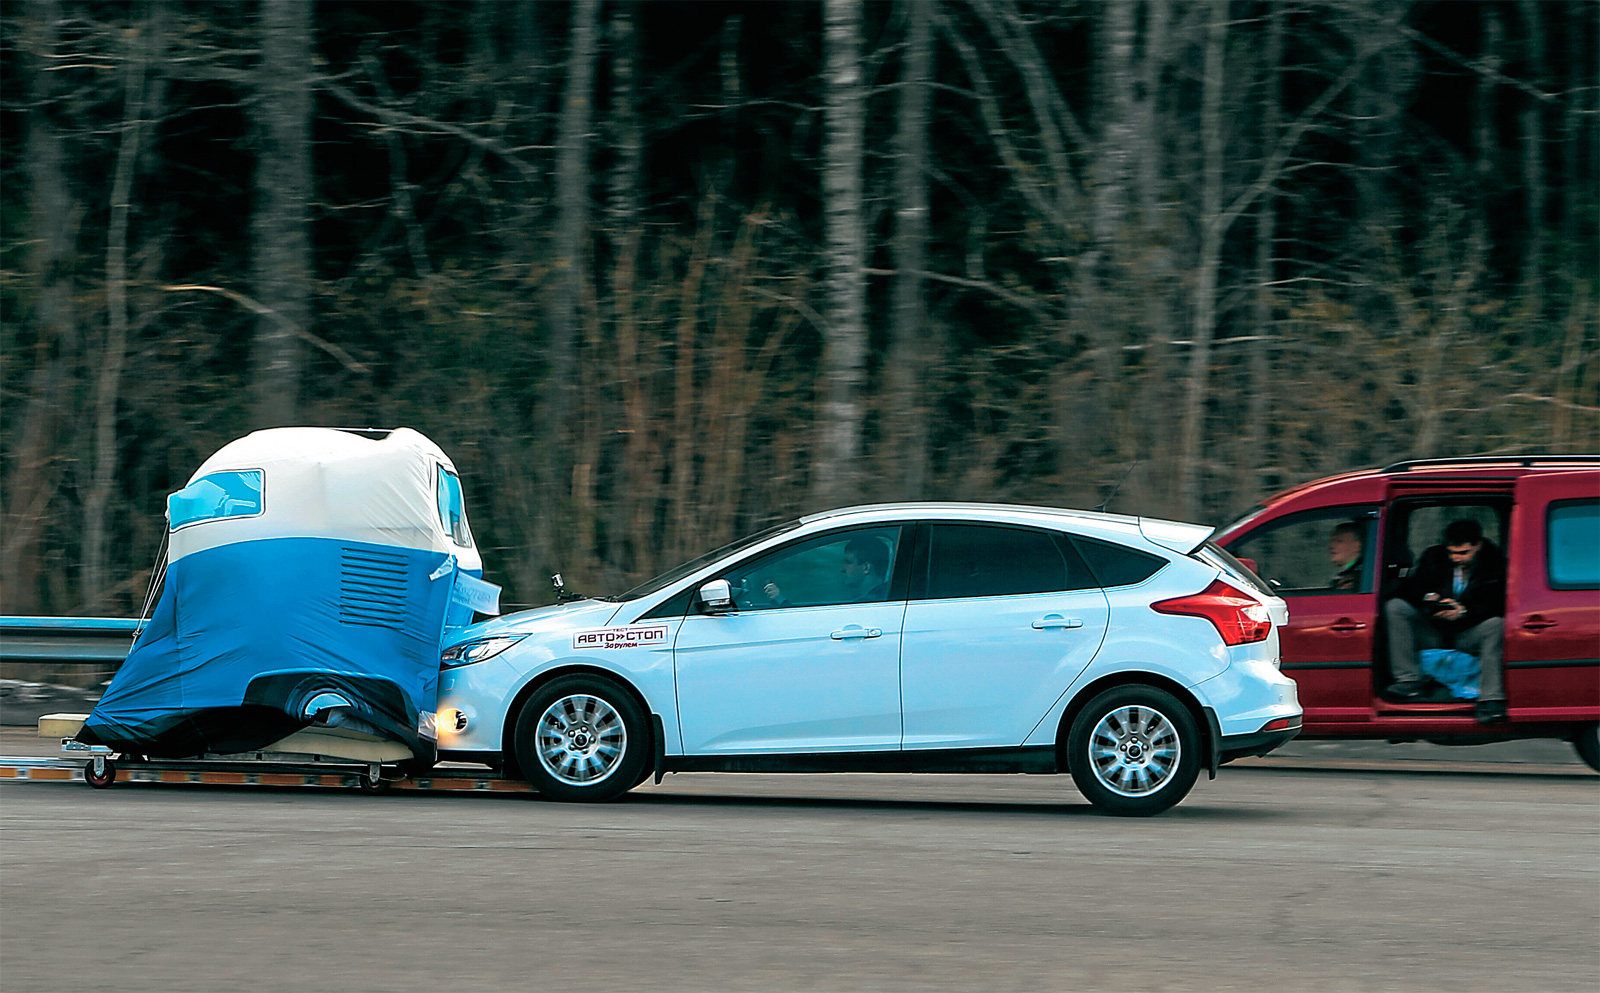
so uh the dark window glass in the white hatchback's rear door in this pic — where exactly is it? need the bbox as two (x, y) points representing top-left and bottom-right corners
(923, 524), (1098, 600)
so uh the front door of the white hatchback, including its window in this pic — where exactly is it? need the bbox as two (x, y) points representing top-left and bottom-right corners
(674, 524), (909, 755)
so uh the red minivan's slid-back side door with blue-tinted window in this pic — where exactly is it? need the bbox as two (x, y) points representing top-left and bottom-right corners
(1506, 472), (1600, 721)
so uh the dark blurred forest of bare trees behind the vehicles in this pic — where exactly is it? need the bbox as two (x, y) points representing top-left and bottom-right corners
(0, 0), (1600, 616)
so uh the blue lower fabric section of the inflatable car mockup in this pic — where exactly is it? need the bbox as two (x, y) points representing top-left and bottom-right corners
(85, 537), (453, 755)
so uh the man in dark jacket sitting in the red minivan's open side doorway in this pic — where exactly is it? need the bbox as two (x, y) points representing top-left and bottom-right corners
(1384, 520), (1506, 724)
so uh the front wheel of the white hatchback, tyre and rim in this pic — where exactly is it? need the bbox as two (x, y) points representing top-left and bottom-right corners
(514, 673), (650, 803)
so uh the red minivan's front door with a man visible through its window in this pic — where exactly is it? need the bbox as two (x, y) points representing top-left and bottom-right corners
(1227, 504), (1381, 723)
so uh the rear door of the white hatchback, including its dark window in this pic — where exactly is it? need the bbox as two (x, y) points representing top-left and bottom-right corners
(901, 521), (1110, 750)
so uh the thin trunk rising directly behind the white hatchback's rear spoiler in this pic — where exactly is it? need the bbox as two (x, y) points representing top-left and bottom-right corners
(1178, 0), (1227, 520)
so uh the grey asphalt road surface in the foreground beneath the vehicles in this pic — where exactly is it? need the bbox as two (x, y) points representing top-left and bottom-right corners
(0, 757), (1600, 993)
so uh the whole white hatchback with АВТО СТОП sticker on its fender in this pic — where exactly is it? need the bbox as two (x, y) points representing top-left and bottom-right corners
(438, 504), (1301, 814)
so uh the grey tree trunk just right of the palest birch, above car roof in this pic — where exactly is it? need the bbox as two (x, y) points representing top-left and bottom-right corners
(888, 0), (934, 500)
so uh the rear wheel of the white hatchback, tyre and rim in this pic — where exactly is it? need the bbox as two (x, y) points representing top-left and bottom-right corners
(1067, 684), (1200, 817)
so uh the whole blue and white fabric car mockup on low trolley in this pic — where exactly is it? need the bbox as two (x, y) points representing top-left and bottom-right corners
(78, 427), (499, 766)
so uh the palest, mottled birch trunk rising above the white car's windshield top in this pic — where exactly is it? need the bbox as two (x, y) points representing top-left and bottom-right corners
(811, 0), (867, 507)
